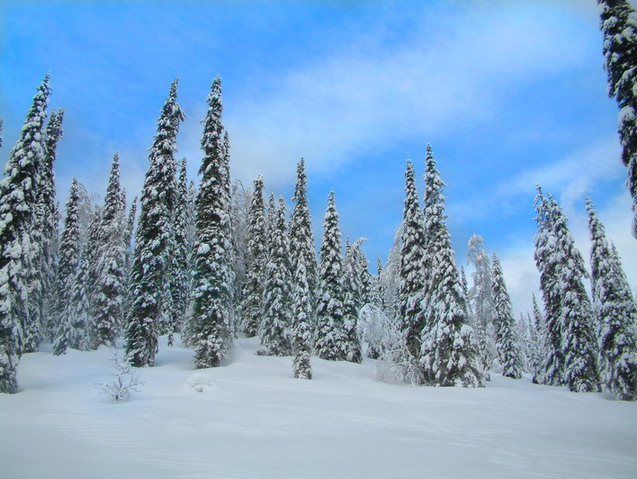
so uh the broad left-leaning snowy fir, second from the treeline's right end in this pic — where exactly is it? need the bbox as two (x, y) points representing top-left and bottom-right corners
(536, 189), (599, 392)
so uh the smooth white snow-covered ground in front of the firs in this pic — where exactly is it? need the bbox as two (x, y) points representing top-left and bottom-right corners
(0, 338), (637, 479)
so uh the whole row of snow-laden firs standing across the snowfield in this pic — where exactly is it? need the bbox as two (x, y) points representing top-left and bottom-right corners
(0, 76), (637, 399)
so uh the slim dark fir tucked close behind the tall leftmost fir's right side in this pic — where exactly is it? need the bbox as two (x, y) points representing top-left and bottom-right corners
(36, 110), (64, 340)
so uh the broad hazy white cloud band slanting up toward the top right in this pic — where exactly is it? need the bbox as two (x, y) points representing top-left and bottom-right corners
(173, 4), (585, 189)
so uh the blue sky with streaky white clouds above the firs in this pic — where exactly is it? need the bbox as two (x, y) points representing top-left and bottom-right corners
(0, 0), (637, 311)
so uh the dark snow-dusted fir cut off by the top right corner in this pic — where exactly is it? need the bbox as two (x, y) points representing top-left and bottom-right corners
(597, 0), (637, 238)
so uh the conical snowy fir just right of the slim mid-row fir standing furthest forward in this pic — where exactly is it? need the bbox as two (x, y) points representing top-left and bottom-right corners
(314, 191), (348, 361)
